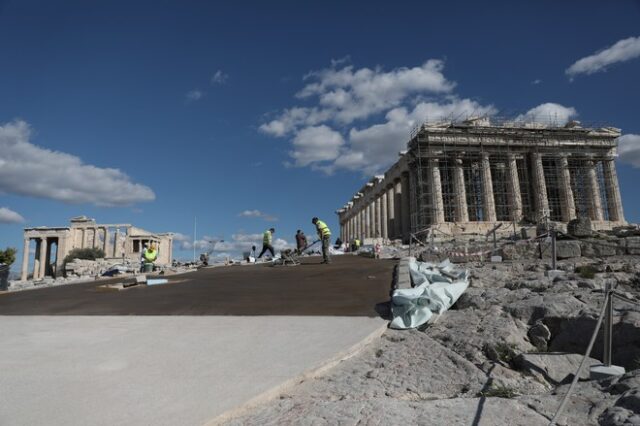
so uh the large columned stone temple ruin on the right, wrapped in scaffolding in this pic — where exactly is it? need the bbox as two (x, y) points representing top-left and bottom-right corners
(336, 118), (626, 242)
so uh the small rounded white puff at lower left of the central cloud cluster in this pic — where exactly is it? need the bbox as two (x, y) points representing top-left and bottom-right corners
(289, 124), (344, 167)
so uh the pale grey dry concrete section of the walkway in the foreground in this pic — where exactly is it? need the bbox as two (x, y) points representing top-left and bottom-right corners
(0, 315), (386, 426)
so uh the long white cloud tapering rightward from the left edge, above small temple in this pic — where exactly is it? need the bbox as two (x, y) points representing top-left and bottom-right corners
(0, 120), (155, 206)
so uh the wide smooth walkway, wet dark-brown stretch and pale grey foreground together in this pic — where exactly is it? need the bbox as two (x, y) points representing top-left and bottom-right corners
(0, 256), (393, 426)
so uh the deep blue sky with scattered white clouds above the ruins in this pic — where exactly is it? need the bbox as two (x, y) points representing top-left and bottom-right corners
(0, 0), (640, 258)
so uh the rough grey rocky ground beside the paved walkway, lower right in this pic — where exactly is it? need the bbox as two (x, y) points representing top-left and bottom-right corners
(224, 256), (640, 425)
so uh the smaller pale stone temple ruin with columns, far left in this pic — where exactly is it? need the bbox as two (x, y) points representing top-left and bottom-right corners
(22, 216), (173, 281)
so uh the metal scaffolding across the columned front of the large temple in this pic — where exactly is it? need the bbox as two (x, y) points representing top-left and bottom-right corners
(408, 118), (615, 238)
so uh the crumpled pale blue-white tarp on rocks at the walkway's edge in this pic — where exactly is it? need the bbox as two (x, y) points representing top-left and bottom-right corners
(389, 259), (469, 329)
